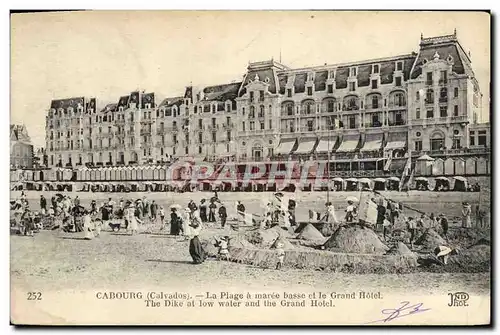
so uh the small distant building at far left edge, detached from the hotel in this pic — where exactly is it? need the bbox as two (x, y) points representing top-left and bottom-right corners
(10, 124), (33, 169)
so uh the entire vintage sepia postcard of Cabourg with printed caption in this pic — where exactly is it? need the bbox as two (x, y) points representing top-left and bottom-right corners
(10, 11), (492, 326)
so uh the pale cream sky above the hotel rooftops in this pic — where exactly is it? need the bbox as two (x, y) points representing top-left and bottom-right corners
(10, 11), (490, 146)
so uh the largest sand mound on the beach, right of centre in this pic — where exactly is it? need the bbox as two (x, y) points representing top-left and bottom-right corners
(323, 226), (388, 254)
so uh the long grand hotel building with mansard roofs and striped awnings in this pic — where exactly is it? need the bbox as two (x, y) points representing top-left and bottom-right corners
(46, 33), (490, 177)
